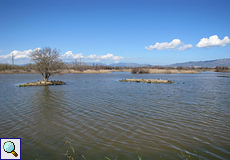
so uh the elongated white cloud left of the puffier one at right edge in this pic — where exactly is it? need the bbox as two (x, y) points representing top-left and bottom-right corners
(145, 39), (182, 50)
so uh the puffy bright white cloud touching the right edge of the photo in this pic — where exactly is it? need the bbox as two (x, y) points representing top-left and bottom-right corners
(196, 35), (230, 48)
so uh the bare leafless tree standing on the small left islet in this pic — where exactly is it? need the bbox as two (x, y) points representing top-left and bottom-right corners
(30, 47), (61, 82)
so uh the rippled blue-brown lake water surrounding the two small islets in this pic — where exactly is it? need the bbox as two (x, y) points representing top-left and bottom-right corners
(0, 72), (230, 160)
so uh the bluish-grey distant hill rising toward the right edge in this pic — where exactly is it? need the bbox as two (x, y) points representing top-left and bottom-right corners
(168, 58), (230, 67)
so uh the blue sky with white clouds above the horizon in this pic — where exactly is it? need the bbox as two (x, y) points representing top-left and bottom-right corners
(0, 0), (230, 65)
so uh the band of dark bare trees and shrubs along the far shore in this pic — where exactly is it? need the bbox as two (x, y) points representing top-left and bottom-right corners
(0, 61), (230, 74)
